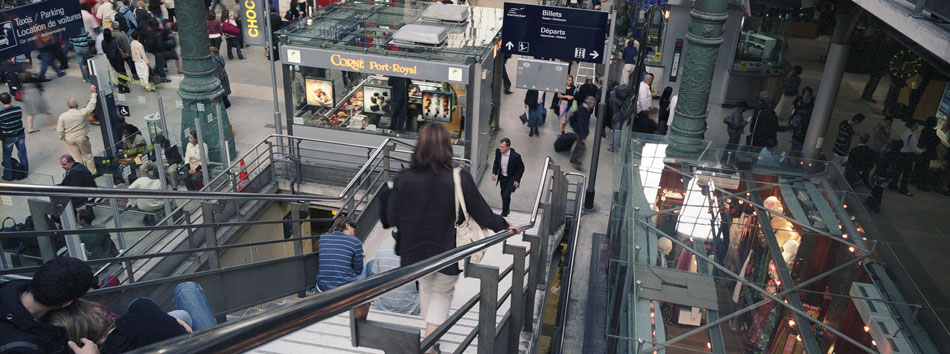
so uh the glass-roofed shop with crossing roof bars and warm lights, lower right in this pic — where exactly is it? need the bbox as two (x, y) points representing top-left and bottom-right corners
(607, 136), (948, 353)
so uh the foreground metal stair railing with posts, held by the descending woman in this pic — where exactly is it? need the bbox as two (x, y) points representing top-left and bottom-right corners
(123, 157), (586, 353)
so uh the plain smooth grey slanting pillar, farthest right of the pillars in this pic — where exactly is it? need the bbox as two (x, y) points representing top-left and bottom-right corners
(802, 1), (861, 158)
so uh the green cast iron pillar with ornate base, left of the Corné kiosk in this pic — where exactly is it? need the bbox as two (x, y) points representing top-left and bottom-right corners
(176, 0), (237, 163)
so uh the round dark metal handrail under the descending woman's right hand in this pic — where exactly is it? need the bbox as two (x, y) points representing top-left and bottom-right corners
(134, 156), (560, 353)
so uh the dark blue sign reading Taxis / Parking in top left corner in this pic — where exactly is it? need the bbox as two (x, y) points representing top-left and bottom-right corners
(0, 0), (83, 60)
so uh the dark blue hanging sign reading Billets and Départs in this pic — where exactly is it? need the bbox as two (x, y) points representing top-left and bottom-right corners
(501, 2), (607, 63)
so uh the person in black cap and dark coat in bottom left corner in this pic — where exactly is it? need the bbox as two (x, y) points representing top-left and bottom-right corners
(0, 257), (98, 353)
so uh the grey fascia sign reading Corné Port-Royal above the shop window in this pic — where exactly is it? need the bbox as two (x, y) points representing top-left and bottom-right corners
(280, 46), (469, 84)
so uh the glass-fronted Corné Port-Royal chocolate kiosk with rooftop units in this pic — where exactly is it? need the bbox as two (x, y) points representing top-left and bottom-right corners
(280, 1), (502, 176)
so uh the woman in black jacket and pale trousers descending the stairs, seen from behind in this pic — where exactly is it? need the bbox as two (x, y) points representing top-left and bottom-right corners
(386, 124), (520, 353)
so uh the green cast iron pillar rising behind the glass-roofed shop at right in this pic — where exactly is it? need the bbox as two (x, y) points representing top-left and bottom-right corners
(666, 0), (729, 157)
